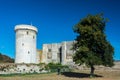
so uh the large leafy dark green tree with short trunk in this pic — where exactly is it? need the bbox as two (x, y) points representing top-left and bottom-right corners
(73, 14), (114, 77)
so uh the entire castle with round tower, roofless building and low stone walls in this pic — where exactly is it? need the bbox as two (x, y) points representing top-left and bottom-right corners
(0, 25), (120, 74)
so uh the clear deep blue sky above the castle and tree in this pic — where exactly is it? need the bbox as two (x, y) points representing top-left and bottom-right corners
(0, 0), (120, 60)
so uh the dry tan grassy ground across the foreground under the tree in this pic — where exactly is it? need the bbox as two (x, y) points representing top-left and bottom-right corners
(0, 71), (120, 80)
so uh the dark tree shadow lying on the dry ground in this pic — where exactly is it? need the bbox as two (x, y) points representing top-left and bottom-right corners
(62, 72), (103, 78)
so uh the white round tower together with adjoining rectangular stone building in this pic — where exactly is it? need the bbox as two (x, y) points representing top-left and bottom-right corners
(15, 25), (74, 65)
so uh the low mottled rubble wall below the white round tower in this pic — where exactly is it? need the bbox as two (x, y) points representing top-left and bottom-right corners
(0, 63), (47, 74)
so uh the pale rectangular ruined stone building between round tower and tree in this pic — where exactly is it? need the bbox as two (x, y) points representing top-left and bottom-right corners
(42, 41), (74, 64)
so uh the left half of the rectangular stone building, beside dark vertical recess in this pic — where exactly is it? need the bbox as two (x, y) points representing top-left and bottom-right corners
(42, 43), (60, 63)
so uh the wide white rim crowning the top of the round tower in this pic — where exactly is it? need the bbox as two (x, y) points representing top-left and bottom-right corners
(15, 24), (38, 32)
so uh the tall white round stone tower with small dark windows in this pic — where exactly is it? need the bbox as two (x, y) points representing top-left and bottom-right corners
(15, 25), (38, 63)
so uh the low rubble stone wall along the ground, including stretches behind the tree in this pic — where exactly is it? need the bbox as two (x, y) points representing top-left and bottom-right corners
(0, 61), (120, 74)
